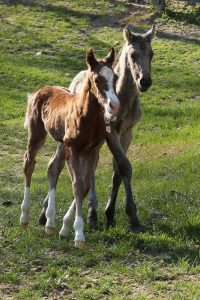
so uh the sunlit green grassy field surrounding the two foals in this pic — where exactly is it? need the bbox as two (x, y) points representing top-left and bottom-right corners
(0, 0), (200, 300)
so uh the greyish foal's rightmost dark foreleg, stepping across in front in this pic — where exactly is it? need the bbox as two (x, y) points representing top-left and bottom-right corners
(106, 129), (140, 233)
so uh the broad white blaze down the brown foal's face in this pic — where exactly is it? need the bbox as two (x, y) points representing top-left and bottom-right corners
(99, 66), (119, 115)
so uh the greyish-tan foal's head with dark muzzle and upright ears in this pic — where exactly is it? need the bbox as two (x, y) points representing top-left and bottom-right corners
(123, 25), (155, 92)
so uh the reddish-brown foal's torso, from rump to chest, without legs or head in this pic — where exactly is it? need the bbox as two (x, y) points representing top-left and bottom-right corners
(29, 86), (105, 151)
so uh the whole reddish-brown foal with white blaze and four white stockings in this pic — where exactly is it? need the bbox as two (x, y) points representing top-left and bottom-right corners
(20, 48), (119, 247)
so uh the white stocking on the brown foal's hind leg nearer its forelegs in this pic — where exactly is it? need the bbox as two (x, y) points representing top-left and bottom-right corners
(45, 189), (56, 228)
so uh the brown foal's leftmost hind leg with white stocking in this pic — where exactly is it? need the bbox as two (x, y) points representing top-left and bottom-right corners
(20, 120), (46, 228)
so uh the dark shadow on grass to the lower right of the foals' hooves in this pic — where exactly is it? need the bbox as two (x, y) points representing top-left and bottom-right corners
(103, 226), (200, 267)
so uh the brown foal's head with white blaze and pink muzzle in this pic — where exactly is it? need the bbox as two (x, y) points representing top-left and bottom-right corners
(86, 48), (119, 121)
